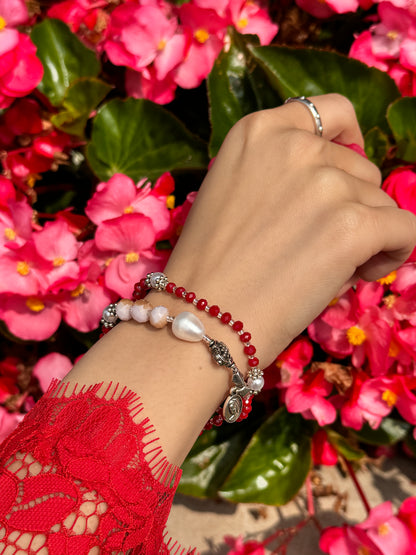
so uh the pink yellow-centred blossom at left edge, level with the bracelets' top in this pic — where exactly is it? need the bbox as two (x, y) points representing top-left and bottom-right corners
(0, 241), (52, 296)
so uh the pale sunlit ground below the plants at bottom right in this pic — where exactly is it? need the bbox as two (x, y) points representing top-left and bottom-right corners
(168, 457), (416, 555)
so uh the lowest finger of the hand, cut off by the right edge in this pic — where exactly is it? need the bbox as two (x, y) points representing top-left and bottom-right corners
(357, 206), (416, 281)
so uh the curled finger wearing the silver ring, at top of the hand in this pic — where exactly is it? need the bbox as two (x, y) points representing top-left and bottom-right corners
(281, 94), (364, 148)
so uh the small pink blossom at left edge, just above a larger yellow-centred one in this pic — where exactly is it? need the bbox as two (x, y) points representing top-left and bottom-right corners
(0, 200), (33, 253)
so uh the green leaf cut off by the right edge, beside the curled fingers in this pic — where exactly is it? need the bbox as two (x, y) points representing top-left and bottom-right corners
(387, 98), (416, 162)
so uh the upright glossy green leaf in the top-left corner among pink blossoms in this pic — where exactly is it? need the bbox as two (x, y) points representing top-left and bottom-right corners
(31, 19), (101, 106)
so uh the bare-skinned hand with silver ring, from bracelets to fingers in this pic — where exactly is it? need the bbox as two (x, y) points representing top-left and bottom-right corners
(162, 95), (416, 366)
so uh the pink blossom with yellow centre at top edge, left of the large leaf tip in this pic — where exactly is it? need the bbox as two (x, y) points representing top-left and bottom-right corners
(174, 3), (227, 89)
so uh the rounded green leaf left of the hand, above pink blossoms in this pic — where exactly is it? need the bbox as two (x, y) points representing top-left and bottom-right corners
(87, 98), (208, 181)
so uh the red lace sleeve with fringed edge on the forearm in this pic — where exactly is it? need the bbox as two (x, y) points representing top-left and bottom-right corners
(0, 381), (195, 555)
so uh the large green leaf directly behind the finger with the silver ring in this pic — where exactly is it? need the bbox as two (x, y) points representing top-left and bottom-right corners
(250, 46), (400, 133)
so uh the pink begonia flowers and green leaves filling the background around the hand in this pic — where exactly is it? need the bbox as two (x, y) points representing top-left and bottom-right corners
(0, 0), (416, 555)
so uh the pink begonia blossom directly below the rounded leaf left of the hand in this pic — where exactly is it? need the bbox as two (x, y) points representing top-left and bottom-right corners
(85, 173), (175, 240)
